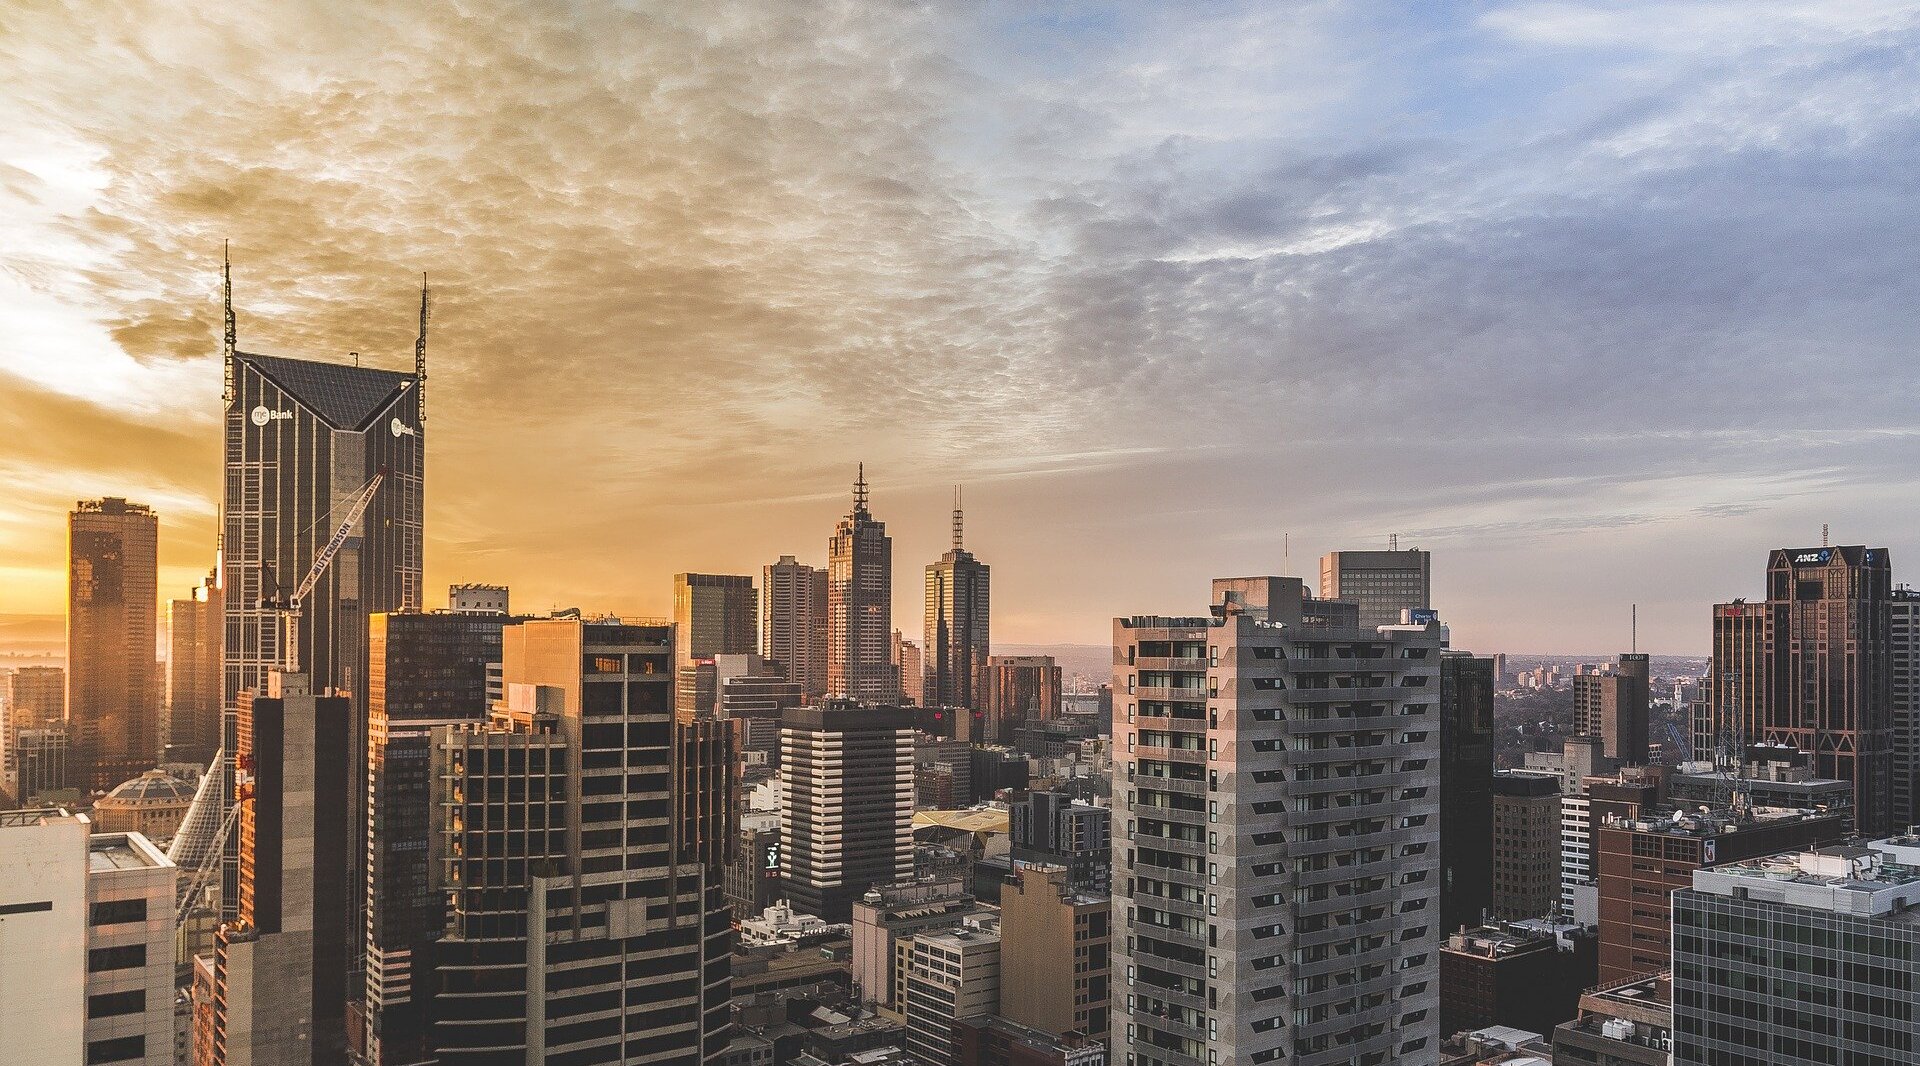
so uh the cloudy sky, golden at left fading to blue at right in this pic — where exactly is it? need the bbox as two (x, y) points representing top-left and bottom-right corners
(0, 0), (1920, 653)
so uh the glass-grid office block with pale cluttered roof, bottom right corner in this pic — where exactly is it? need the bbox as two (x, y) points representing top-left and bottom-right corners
(1672, 837), (1920, 1066)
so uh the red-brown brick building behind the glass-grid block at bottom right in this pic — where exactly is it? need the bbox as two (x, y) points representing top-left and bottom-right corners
(1594, 807), (1841, 981)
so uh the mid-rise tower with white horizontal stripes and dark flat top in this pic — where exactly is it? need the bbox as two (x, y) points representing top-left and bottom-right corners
(780, 701), (914, 922)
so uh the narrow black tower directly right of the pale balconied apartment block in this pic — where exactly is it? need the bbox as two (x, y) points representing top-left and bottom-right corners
(1440, 651), (1494, 937)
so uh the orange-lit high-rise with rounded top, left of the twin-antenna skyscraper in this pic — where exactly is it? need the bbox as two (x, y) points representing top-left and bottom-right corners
(67, 497), (161, 791)
